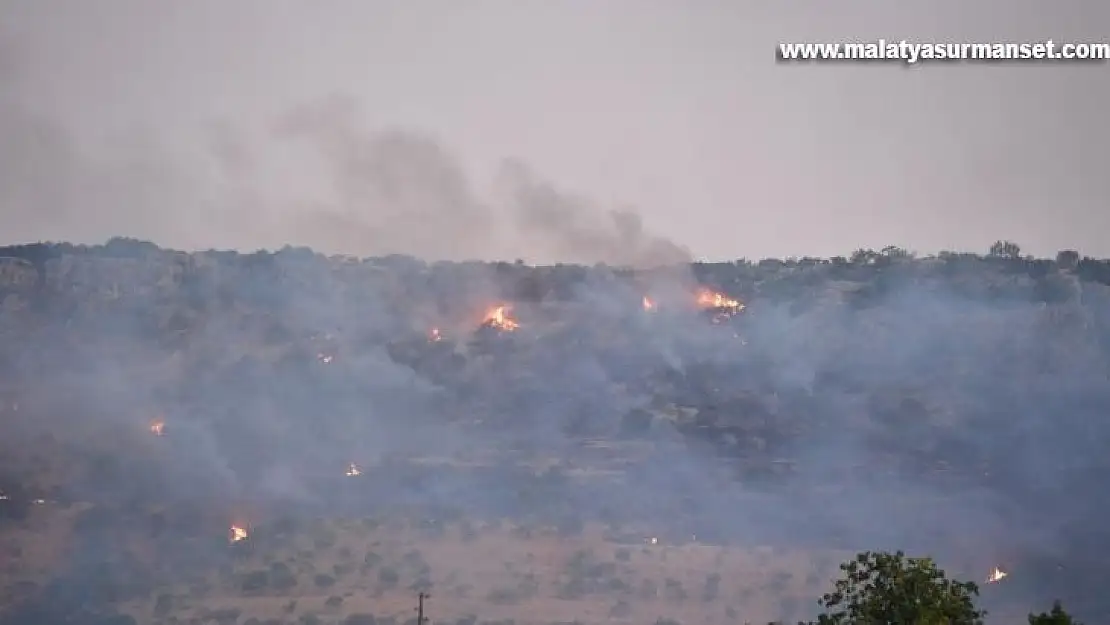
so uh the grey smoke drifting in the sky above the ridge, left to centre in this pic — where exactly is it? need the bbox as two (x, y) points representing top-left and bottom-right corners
(0, 48), (689, 266)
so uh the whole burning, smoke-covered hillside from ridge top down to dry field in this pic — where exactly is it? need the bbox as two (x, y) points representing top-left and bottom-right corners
(0, 239), (1110, 625)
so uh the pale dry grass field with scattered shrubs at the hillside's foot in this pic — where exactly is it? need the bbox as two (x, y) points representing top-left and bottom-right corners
(114, 521), (850, 624)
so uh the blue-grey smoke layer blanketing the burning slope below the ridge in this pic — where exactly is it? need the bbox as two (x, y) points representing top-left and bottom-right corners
(3, 242), (1110, 621)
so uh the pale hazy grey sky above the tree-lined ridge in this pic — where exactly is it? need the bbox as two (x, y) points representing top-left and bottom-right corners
(0, 0), (1110, 260)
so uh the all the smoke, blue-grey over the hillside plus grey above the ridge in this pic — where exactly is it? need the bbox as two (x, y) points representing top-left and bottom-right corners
(0, 30), (1110, 625)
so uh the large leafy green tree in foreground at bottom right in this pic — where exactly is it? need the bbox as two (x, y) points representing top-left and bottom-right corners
(817, 552), (987, 625)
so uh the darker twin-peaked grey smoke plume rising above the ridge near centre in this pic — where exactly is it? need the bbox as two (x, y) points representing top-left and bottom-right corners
(268, 98), (690, 266)
